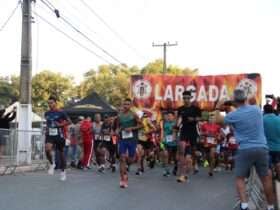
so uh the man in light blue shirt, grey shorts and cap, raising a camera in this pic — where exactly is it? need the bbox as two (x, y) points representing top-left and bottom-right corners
(216, 89), (274, 210)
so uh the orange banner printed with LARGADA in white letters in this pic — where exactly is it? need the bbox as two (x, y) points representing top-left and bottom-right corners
(130, 73), (261, 110)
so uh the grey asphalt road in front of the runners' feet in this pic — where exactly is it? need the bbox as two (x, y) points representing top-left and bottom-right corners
(0, 168), (236, 210)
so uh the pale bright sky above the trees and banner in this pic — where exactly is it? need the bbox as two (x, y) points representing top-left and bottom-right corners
(0, 0), (280, 95)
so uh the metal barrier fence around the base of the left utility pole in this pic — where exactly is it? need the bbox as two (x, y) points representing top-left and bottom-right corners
(0, 129), (46, 175)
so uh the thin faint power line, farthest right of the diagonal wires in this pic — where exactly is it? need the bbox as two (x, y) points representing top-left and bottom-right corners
(77, 0), (145, 60)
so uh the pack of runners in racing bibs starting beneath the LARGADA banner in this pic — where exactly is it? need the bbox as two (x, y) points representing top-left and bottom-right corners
(45, 91), (237, 188)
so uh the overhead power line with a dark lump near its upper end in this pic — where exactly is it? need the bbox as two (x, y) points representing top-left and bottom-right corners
(38, 0), (123, 65)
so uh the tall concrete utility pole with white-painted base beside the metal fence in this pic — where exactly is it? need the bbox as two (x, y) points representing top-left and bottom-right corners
(17, 0), (33, 164)
